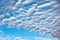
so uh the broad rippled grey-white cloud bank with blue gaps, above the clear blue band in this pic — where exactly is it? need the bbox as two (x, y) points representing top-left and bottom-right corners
(0, 0), (60, 38)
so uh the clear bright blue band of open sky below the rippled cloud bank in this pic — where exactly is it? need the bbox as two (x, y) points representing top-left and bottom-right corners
(0, 26), (57, 40)
